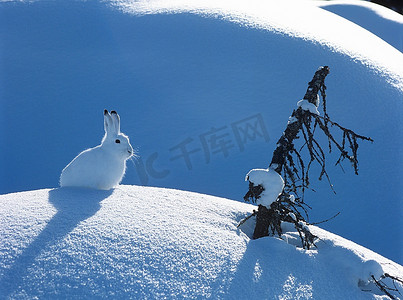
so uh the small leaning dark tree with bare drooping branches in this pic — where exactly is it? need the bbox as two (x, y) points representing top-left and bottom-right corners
(244, 66), (372, 249)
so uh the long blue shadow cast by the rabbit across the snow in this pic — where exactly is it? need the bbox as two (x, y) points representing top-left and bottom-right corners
(0, 188), (113, 296)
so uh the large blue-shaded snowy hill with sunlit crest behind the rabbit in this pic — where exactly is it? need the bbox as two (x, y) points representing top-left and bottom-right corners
(0, 0), (403, 264)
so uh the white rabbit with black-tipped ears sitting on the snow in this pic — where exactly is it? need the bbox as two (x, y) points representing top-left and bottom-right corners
(60, 109), (133, 190)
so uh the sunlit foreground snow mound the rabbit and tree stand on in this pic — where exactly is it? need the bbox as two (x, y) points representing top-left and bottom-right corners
(0, 186), (403, 299)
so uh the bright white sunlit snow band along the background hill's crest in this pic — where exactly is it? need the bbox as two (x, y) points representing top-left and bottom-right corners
(111, 0), (403, 89)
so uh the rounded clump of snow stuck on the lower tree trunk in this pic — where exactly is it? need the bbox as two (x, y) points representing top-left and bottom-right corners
(245, 169), (284, 208)
